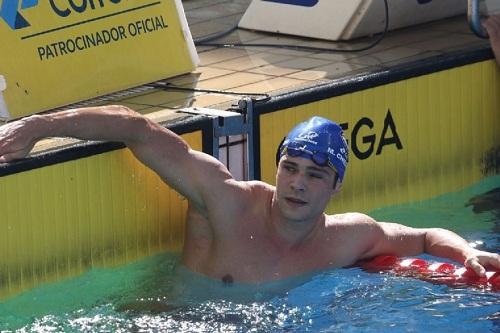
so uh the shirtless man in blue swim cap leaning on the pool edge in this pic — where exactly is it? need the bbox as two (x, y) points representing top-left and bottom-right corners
(0, 106), (500, 283)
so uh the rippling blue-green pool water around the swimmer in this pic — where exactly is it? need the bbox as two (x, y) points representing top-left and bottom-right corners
(0, 177), (500, 333)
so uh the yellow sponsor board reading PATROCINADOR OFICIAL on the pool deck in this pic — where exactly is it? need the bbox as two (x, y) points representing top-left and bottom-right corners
(0, 0), (198, 118)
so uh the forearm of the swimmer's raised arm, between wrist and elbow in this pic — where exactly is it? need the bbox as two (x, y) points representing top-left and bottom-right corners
(28, 106), (150, 143)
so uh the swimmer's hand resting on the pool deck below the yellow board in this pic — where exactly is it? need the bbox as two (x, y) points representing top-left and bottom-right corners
(0, 117), (38, 163)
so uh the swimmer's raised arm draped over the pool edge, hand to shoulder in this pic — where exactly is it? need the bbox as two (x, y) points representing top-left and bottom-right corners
(0, 106), (232, 211)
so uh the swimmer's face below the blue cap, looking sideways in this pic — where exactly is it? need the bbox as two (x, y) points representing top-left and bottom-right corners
(276, 155), (335, 222)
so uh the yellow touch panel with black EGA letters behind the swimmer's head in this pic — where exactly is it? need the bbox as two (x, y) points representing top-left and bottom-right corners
(260, 61), (500, 213)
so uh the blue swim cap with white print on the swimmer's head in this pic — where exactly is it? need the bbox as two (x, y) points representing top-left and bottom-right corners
(276, 117), (349, 182)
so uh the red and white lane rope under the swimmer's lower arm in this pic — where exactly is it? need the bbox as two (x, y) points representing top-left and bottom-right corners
(360, 256), (500, 290)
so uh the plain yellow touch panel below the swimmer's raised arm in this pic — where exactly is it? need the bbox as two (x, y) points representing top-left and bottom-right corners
(0, 132), (202, 297)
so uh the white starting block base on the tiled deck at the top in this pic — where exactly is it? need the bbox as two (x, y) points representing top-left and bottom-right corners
(238, 0), (467, 40)
